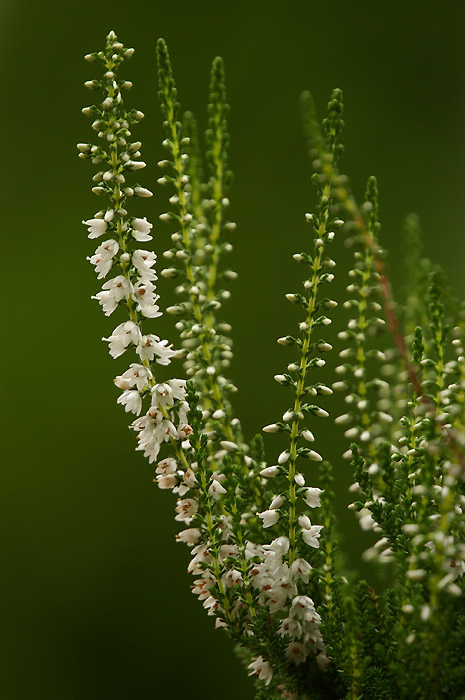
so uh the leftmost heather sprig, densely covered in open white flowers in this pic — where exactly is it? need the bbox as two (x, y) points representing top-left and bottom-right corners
(78, 32), (248, 640)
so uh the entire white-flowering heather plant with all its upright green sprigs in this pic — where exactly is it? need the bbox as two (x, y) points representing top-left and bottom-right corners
(78, 32), (465, 700)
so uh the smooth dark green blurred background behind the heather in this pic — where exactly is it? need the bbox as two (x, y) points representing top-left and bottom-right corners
(0, 0), (465, 700)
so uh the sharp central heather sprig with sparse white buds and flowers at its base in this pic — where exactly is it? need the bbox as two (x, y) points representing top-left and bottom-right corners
(246, 93), (342, 684)
